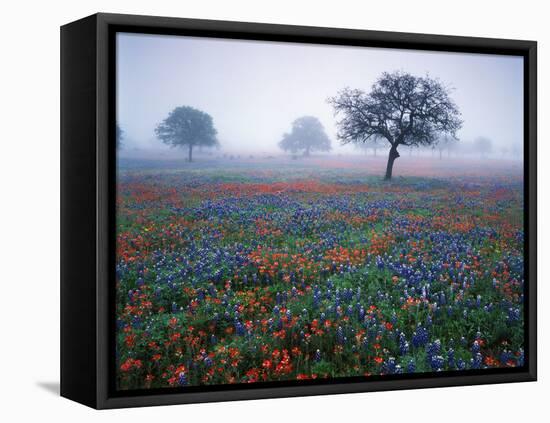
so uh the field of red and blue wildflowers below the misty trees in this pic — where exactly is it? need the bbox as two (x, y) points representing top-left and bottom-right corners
(116, 159), (524, 390)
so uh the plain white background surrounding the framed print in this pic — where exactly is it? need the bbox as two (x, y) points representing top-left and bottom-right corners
(0, 0), (550, 423)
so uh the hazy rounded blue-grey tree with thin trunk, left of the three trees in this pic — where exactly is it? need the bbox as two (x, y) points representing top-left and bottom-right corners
(155, 106), (218, 162)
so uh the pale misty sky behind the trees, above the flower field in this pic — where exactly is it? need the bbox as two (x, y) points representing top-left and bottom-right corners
(117, 33), (523, 158)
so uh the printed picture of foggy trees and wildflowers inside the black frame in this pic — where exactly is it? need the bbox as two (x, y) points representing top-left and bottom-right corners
(113, 33), (525, 391)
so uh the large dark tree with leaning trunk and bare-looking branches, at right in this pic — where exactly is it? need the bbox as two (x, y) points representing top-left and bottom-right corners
(328, 72), (462, 180)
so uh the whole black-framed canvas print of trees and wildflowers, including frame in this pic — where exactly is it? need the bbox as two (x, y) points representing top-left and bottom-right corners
(61, 14), (536, 408)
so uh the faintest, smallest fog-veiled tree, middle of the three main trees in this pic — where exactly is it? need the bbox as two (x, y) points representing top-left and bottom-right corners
(279, 116), (331, 156)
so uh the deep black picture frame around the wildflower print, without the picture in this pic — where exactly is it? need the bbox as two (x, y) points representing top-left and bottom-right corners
(61, 13), (537, 409)
